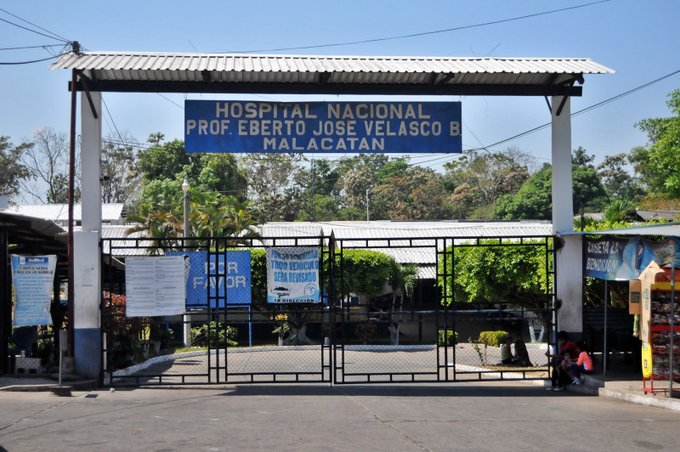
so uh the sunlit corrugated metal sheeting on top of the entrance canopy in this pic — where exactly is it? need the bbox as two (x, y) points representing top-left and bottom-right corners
(50, 52), (612, 75)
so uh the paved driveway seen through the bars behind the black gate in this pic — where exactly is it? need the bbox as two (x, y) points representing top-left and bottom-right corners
(114, 343), (547, 384)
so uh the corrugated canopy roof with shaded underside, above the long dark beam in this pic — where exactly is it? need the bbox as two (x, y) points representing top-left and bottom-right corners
(50, 52), (614, 93)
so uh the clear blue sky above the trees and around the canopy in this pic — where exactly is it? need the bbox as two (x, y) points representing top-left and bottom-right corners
(0, 0), (680, 170)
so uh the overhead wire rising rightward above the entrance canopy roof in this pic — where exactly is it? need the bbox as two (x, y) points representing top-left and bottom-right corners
(228, 0), (610, 53)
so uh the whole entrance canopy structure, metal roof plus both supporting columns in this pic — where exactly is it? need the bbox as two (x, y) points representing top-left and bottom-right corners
(51, 48), (613, 376)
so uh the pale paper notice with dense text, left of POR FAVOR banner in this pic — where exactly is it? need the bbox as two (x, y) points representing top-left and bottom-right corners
(125, 256), (186, 317)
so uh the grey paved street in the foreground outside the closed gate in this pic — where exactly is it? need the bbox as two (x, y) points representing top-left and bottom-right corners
(0, 382), (680, 451)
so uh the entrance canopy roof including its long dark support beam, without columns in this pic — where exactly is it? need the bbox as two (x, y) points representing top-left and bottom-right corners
(50, 51), (613, 96)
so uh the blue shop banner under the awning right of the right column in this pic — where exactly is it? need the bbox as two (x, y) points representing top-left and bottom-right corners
(586, 237), (680, 281)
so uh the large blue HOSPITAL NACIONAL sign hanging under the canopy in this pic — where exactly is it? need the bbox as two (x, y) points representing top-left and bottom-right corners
(184, 100), (463, 154)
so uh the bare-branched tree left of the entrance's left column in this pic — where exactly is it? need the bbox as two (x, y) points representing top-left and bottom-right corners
(21, 127), (80, 204)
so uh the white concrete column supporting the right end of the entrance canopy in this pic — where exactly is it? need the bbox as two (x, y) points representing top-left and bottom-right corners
(552, 96), (583, 333)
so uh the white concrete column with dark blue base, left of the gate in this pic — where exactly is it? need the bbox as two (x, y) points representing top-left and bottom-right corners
(73, 92), (102, 378)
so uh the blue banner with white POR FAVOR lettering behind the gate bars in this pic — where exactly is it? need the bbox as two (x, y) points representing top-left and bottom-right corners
(165, 250), (251, 308)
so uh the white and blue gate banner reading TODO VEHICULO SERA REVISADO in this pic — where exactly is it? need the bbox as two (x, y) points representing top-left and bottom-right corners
(267, 246), (321, 304)
